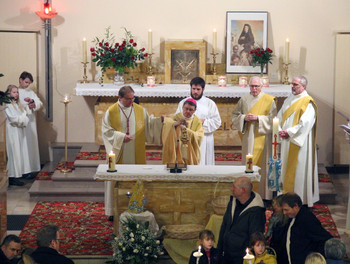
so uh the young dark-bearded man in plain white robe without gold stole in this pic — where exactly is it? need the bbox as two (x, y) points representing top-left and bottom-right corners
(176, 77), (221, 165)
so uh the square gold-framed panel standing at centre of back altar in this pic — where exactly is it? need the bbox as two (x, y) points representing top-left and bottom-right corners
(165, 40), (206, 83)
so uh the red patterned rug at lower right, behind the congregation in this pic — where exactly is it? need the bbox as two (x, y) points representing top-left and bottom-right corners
(266, 204), (340, 238)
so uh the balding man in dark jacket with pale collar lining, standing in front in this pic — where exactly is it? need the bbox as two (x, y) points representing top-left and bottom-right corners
(218, 177), (266, 264)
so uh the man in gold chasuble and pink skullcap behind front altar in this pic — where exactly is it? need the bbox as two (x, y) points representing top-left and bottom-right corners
(162, 98), (204, 165)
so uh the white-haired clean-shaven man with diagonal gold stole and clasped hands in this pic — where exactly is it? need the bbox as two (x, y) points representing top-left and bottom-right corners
(232, 76), (277, 200)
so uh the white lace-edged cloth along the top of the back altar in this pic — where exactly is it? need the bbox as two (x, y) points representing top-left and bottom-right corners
(75, 83), (291, 98)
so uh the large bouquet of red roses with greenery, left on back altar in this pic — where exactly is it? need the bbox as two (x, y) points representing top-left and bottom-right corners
(90, 27), (148, 72)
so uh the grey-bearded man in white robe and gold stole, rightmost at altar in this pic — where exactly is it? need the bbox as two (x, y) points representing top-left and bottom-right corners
(278, 76), (319, 207)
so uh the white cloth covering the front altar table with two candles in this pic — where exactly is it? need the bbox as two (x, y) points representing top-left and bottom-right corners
(94, 164), (260, 182)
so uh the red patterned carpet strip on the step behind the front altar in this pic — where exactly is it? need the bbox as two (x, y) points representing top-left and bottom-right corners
(76, 151), (242, 161)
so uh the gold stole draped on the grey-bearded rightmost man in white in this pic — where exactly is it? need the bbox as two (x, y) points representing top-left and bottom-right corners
(281, 96), (317, 193)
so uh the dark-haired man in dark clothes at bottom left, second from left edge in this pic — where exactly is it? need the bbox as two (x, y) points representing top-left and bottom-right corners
(31, 225), (74, 264)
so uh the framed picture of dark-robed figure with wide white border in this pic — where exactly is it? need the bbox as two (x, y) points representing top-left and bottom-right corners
(226, 12), (267, 74)
